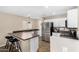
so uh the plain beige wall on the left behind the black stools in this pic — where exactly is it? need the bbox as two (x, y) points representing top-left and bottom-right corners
(0, 13), (24, 46)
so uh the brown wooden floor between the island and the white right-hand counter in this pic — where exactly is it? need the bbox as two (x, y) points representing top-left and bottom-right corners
(39, 40), (50, 52)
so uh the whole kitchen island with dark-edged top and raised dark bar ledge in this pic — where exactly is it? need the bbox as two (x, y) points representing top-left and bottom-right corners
(9, 29), (39, 52)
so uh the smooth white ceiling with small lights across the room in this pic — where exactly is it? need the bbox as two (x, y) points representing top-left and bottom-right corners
(0, 6), (76, 18)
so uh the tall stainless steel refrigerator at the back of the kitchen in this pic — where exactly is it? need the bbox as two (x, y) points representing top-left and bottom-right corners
(42, 22), (51, 42)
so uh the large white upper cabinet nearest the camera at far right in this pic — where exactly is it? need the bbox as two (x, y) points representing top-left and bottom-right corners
(67, 8), (78, 28)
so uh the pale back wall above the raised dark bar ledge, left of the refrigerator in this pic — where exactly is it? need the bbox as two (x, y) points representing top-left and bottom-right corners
(22, 19), (41, 29)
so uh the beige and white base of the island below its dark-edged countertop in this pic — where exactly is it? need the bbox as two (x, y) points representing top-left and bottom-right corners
(20, 37), (39, 52)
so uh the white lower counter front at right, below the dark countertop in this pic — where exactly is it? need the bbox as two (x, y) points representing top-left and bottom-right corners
(50, 36), (79, 52)
